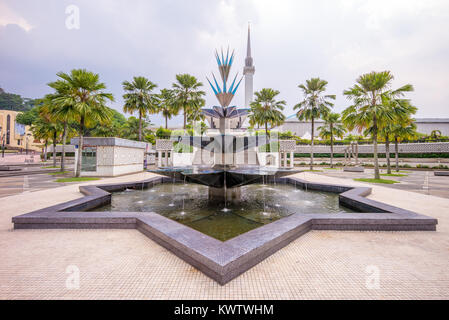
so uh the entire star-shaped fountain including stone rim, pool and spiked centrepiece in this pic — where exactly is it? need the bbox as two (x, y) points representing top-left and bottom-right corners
(12, 45), (438, 284)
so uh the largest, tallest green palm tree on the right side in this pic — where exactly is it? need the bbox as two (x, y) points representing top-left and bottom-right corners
(343, 71), (413, 179)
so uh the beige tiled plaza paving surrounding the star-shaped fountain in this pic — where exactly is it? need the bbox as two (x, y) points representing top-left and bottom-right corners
(0, 173), (449, 299)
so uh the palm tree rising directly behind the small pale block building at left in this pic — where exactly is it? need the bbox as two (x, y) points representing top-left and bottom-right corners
(122, 77), (157, 141)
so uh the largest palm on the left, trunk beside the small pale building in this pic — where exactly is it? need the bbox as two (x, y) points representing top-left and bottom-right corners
(53, 69), (114, 177)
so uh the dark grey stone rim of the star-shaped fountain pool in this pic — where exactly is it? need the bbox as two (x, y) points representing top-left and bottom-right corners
(12, 177), (438, 285)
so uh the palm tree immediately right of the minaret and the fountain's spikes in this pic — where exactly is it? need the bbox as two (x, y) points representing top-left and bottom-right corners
(250, 88), (286, 137)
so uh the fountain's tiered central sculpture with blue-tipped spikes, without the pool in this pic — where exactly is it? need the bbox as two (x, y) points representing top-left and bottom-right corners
(149, 49), (299, 203)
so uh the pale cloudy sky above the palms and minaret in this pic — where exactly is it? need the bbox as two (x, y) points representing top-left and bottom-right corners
(0, 0), (449, 126)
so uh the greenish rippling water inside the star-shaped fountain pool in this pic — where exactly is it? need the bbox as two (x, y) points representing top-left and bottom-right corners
(94, 183), (352, 241)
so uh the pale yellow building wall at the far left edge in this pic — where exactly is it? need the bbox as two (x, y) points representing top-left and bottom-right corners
(0, 110), (41, 151)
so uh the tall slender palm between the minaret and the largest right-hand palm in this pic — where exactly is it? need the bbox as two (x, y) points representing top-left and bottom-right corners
(293, 78), (336, 170)
